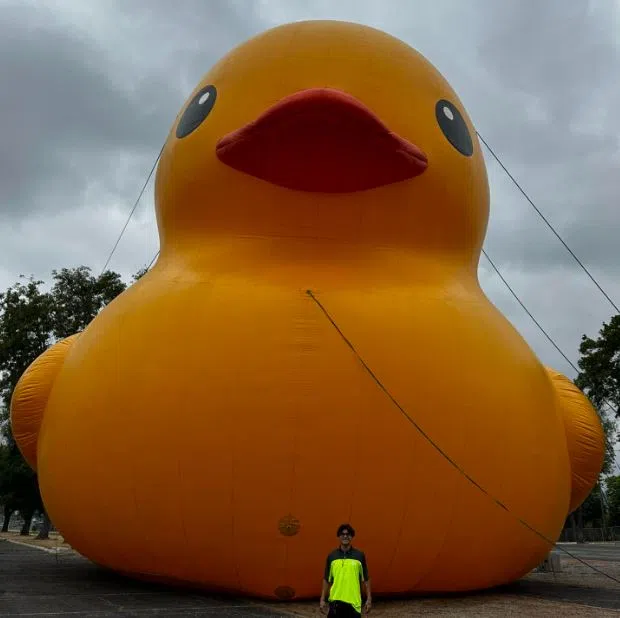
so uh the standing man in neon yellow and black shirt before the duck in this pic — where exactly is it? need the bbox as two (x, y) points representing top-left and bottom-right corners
(319, 524), (372, 618)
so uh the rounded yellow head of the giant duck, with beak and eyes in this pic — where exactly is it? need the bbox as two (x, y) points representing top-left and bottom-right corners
(156, 21), (489, 264)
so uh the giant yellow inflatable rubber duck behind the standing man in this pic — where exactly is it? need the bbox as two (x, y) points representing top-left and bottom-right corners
(11, 21), (604, 599)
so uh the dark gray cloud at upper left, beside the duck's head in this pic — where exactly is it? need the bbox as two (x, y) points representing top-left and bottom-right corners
(0, 5), (160, 218)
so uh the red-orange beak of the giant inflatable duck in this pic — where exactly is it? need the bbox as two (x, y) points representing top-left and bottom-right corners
(216, 88), (428, 193)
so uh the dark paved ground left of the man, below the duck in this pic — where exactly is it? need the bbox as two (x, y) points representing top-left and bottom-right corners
(0, 540), (290, 618)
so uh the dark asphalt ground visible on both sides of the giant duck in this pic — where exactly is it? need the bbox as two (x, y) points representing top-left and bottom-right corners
(0, 540), (620, 618)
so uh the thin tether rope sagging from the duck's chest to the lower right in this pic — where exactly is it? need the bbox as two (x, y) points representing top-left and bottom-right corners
(306, 290), (620, 584)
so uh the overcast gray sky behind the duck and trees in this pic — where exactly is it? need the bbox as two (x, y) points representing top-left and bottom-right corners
(0, 0), (620, 418)
